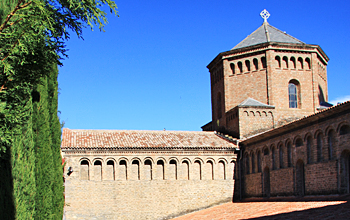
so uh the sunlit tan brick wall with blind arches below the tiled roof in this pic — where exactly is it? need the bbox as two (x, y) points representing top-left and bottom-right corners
(63, 152), (236, 219)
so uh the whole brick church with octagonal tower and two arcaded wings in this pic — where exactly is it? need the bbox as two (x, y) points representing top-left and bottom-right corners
(61, 10), (350, 219)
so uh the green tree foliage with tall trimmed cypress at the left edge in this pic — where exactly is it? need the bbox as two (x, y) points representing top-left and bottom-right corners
(0, 0), (117, 219)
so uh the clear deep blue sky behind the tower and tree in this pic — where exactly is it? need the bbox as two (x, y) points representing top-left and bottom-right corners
(58, 0), (350, 131)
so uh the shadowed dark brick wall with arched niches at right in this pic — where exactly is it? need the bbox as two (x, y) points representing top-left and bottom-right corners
(241, 110), (350, 196)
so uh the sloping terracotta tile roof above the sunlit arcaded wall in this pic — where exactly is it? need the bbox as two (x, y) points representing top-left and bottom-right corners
(61, 128), (236, 149)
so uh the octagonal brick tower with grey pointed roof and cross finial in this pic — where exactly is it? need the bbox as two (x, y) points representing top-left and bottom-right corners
(202, 10), (330, 138)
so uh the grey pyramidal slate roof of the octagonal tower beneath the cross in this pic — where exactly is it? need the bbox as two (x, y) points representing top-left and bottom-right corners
(232, 21), (305, 50)
